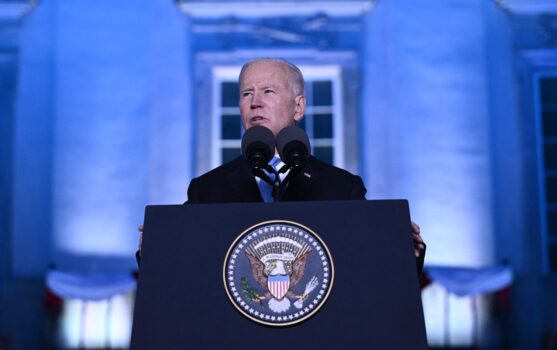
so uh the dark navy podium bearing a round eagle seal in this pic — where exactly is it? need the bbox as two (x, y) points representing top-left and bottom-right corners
(131, 200), (427, 349)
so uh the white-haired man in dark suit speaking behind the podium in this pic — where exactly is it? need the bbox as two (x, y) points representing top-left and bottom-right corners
(137, 58), (425, 262)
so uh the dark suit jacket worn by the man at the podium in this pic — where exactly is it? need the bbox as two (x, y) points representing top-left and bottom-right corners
(187, 156), (366, 203)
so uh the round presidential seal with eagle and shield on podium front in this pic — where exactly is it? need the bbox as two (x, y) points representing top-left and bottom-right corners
(223, 221), (334, 326)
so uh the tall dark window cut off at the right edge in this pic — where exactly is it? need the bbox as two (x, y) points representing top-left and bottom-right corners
(539, 77), (557, 272)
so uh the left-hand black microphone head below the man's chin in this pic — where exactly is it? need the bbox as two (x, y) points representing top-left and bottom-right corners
(242, 125), (276, 168)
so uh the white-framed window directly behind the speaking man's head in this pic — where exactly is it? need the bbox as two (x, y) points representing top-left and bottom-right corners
(211, 66), (344, 167)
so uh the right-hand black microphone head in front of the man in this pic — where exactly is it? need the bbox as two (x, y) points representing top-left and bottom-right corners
(277, 125), (310, 169)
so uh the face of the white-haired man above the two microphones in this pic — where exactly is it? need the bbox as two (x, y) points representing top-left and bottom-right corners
(240, 62), (306, 135)
